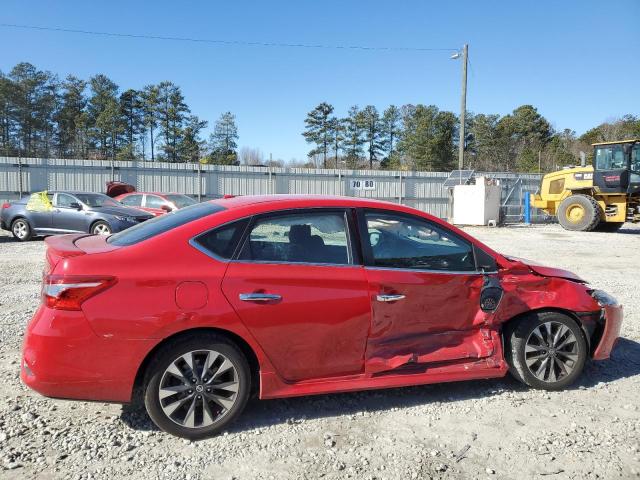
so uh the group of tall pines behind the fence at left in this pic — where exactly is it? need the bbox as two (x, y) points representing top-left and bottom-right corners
(0, 63), (238, 164)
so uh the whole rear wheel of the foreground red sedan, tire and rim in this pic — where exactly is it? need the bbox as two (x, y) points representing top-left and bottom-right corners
(144, 334), (251, 440)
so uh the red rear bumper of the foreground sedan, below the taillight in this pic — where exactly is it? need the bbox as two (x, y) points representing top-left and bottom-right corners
(20, 306), (151, 402)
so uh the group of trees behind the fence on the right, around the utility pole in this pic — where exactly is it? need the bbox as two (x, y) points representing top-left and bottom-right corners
(302, 102), (640, 172)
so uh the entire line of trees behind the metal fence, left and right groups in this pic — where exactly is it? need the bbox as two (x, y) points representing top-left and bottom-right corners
(0, 63), (640, 172)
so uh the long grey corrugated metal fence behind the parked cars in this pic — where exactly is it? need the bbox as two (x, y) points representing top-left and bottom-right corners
(0, 157), (545, 223)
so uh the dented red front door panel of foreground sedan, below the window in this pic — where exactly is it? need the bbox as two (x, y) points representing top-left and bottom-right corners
(366, 268), (493, 373)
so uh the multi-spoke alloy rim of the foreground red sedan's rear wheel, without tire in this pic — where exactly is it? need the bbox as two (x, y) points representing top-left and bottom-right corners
(158, 350), (240, 428)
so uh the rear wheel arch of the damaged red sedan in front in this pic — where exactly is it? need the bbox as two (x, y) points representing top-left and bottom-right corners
(131, 326), (260, 404)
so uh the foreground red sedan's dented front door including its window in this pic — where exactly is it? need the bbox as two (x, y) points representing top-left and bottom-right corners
(359, 210), (497, 374)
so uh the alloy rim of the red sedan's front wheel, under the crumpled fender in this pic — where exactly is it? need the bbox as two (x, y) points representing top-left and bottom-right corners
(525, 321), (578, 383)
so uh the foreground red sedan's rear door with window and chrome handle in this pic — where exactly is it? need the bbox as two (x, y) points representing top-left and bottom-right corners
(222, 209), (370, 381)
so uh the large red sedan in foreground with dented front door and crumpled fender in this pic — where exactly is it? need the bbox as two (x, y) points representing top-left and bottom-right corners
(21, 195), (622, 439)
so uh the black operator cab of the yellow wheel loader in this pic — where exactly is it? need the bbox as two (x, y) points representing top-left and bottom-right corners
(593, 140), (640, 195)
